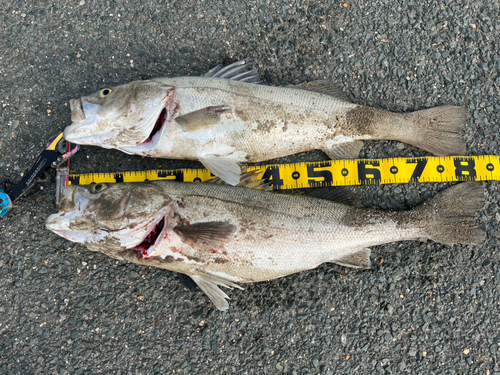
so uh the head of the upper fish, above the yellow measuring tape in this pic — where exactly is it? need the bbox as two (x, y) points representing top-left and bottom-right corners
(64, 80), (174, 153)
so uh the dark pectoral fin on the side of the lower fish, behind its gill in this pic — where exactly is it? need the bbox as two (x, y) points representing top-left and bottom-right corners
(173, 221), (236, 251)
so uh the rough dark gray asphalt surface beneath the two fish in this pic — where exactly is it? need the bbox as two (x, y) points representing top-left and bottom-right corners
(0, 0), (500, 375)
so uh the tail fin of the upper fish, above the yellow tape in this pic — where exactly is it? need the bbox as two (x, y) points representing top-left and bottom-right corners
(401, 106), (467, 156)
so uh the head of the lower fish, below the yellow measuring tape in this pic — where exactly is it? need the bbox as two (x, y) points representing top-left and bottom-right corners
(45, 183), (173, 258)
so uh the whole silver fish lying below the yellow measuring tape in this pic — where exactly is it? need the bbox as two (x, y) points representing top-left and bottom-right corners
(45, 181), (485, 311)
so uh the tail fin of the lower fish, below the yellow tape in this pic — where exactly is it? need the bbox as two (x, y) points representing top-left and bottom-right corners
(421, 182), (486, 245)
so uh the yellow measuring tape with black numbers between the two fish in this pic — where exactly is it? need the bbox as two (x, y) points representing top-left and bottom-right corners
(67, 155), (500, 190)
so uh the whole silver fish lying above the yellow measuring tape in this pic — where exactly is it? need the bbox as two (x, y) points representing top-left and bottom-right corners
(64, 60), (466, 185)
